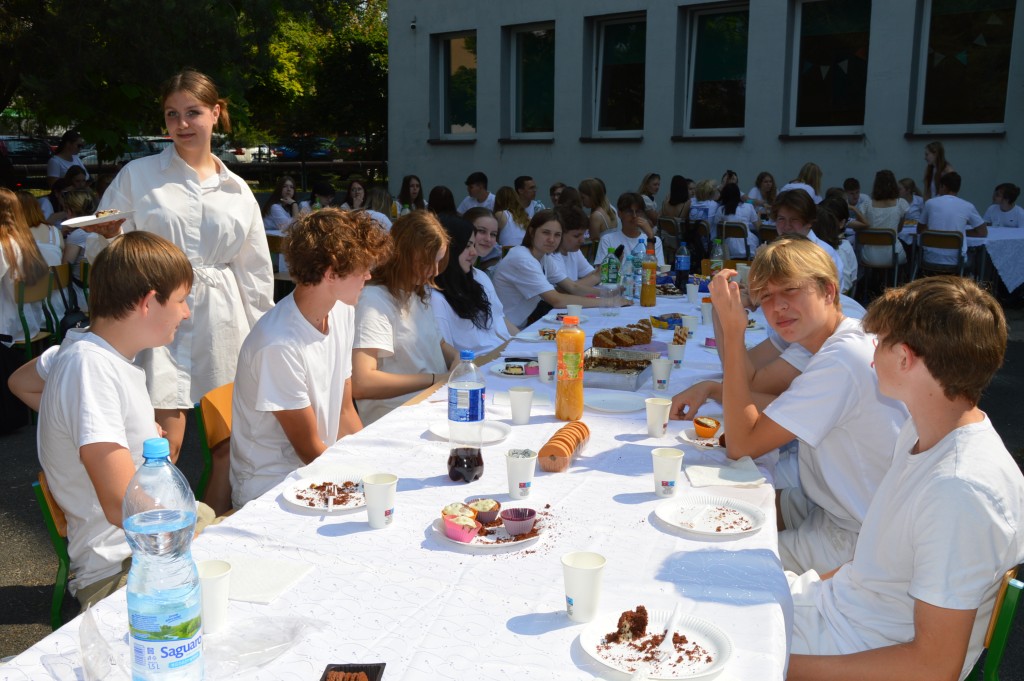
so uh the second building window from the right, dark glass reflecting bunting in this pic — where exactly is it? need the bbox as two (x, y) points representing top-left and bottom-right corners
(793, 0), (871, 128)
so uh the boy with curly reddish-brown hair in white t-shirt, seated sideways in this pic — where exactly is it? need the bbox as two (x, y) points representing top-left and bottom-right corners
(230, 208), (391, 508)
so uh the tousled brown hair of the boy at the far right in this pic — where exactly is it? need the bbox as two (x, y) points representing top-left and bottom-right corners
(864, 270), (1007, 406)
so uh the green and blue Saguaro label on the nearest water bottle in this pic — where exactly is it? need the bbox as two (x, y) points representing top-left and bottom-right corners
(128, 606), (203, 674)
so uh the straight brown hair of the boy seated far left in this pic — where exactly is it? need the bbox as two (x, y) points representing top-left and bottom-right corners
(89, 231), (193, 320)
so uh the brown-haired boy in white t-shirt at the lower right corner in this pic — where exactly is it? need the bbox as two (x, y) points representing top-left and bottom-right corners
(787, 276), (1024, 681)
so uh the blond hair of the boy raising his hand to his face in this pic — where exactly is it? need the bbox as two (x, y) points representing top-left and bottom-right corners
(749, 232), (842, 309)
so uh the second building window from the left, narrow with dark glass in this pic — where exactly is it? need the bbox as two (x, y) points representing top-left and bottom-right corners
(512, 26), (555, 136)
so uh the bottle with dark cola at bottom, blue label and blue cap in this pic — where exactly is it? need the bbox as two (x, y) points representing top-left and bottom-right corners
(449, 350), (486, 482)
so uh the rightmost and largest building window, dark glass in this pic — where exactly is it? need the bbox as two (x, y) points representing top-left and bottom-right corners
(919, 0), (1016, 126)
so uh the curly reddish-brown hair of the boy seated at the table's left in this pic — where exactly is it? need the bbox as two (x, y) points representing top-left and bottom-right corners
(284, 208), (391, 286)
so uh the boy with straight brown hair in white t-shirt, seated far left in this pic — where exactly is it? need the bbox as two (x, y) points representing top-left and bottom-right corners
(11, 231), (196, 607)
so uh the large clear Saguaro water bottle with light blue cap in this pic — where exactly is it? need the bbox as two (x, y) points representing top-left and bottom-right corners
(122, 437), (203, 681)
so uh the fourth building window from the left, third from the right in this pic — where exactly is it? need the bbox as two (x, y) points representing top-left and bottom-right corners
(688, 8), (750, 129)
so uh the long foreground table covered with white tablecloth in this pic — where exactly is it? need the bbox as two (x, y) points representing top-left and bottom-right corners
(0, 299), (792, 681)
